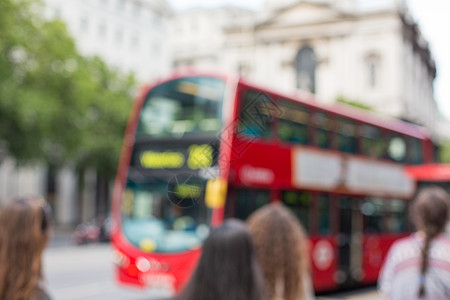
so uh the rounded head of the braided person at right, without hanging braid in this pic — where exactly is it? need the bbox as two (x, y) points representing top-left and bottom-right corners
(411, 186), (450, 238)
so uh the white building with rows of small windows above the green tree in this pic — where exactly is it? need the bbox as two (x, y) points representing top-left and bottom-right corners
(44, 0), (172, 81)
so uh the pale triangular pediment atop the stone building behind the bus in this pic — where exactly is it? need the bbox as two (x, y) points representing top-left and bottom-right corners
(258, 1), (345, 29)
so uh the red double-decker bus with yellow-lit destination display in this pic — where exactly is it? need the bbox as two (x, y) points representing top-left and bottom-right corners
(112, 72), (433, 291)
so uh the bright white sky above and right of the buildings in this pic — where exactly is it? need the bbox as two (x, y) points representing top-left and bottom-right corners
(168, 0), (450, 120)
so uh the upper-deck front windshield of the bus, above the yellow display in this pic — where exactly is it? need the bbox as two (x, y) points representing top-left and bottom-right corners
(137, 77), (225, 138)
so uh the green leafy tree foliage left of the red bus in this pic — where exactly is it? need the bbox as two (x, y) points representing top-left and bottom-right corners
(0, 0), (135, 176)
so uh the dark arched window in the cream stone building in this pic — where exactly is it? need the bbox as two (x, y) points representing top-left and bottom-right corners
(295, 46), (317, 93)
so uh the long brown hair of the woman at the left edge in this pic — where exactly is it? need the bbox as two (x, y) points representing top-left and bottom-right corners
(0, 197), (49, 300)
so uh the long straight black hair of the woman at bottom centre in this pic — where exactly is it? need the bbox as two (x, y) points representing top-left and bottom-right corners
(177, 219), (267, 300)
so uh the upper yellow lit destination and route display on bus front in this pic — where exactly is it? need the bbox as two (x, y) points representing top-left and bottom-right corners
(139, 144), (214, 170)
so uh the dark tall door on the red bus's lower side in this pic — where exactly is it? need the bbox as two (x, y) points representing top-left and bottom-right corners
(336, 196), (363, 287)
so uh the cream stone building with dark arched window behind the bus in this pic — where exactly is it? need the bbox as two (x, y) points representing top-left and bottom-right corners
(173, 0), (438, 138)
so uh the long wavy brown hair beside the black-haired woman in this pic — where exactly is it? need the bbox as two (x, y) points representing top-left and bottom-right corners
(247, 203), (307, 300)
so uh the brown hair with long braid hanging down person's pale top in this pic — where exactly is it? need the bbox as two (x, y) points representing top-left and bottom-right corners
(411, 186), (449, 298)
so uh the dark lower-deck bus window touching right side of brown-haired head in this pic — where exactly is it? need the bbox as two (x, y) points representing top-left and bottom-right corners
(281, 191), (312, 231)
